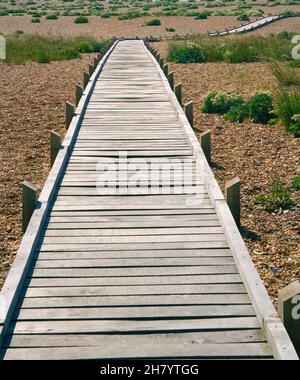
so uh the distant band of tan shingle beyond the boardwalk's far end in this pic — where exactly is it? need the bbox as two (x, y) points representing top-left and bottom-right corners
(0, 14), (300, 38)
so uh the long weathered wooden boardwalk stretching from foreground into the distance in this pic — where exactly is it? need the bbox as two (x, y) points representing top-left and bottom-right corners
(1, 40), (296, 359)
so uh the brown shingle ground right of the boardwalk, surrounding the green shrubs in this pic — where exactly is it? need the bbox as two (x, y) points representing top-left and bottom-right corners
(154, 43), (300, 304)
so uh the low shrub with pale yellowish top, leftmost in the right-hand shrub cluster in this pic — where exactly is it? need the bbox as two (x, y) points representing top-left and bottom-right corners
(202, 92), (244, 114)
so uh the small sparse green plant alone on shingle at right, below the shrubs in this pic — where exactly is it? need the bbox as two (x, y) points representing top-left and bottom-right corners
(254, 178), (294, 212)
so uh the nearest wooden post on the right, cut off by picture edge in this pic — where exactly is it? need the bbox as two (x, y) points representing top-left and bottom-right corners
(278, 281), (300, 354)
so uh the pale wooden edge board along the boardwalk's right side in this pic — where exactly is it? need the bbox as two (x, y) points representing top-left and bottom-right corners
(147, 43), (298, 360)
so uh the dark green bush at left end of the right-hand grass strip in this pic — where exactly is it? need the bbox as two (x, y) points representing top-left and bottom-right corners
(167, 42), (205, 63)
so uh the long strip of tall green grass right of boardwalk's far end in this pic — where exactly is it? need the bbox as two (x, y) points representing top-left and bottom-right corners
(167, 35), (293, 63)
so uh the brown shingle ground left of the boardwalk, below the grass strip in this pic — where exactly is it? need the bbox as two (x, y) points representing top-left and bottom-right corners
(0, 55), (93, 287)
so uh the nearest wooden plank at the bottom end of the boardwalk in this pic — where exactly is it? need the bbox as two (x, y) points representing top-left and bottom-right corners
(0, 337), (272, 360)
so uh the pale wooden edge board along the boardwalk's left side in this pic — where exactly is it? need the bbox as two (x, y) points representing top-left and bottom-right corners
(0, 40), (119, 347)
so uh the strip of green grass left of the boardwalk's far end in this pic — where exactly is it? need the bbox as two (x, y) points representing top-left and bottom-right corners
(5, 34), (109, 64)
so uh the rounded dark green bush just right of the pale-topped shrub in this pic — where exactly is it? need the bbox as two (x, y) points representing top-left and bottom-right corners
(248, 92), (274, 124)
